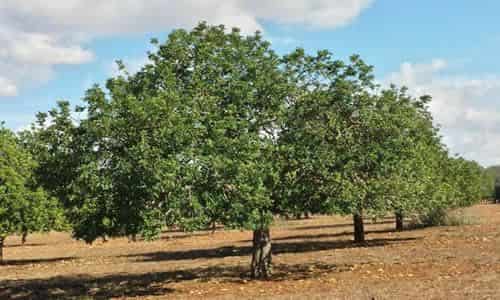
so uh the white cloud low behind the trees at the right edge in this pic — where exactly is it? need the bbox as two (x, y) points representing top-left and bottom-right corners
(385, 59), (500, 165)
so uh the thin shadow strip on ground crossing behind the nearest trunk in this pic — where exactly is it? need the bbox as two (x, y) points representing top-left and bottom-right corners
(120, 238), (422, 262)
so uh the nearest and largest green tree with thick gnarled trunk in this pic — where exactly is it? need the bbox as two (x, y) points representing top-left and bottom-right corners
(67, 23), (288, 277)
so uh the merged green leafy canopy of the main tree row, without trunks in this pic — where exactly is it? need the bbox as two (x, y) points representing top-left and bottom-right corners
(21, 23), (484, 246)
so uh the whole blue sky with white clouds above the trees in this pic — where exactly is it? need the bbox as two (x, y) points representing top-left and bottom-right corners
(0, 0), (500, 166)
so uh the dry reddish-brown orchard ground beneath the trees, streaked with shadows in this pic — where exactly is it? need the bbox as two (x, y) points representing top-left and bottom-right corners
(0, 205), (500, 300)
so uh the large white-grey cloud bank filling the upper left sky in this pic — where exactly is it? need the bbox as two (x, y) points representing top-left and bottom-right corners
(0, 0), (374, 96)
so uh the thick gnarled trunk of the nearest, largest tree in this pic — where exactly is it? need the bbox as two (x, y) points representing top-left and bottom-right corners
(251, 228), (272, 278)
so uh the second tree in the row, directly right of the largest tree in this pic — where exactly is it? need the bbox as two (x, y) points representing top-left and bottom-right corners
(280, 49), (400, 241)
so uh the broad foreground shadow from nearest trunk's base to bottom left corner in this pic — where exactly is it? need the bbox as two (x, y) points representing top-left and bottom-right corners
(0, 263), (352, 299)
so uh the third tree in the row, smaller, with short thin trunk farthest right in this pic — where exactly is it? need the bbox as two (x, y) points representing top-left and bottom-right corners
(372, 90), (444, 231)
